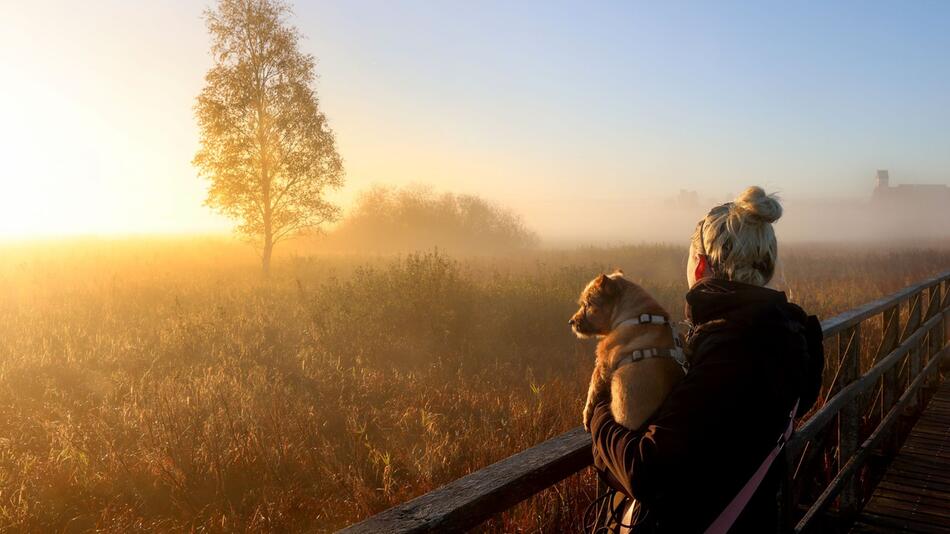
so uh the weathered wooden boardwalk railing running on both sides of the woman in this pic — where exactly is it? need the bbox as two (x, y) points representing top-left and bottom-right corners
(340, 272), (950, 534)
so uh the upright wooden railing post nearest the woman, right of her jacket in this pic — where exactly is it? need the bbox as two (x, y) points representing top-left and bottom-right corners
(838, 323), (862, 521)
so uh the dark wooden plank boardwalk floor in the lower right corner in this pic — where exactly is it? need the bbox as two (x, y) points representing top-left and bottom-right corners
(852, 381), (950, 533)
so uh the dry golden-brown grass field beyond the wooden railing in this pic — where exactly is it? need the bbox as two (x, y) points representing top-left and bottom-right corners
(0, 239), (950, 532)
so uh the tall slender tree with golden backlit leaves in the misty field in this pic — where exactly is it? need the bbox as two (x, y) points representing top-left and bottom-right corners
(193, 0), (343, 274)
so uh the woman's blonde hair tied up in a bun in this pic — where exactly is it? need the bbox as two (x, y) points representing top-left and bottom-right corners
(692, 186), (782, 286)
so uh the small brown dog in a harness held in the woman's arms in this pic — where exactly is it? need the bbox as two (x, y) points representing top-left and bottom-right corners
(569, 272), (685, 430)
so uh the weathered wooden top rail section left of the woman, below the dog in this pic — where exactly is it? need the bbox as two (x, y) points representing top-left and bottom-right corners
(340, 427), (592, 534)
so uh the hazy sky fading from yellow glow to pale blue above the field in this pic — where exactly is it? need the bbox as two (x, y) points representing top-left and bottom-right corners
(0, 0), (950, 236)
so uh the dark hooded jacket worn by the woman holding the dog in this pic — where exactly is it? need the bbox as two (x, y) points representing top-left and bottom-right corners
(591, 280), (824, 534)
